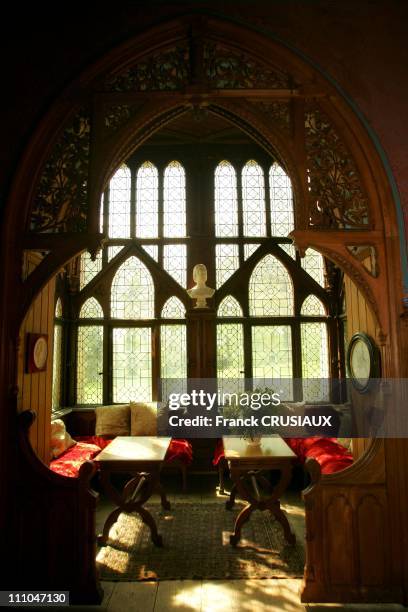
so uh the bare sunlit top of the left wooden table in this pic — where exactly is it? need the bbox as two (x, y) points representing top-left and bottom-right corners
(94, 436), (171, 463)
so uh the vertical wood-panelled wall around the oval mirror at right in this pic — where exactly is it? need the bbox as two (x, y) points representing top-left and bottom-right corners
(344, 275), (378, 459)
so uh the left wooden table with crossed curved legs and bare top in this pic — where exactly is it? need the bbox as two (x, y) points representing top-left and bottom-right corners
(94, 436), (171, 546)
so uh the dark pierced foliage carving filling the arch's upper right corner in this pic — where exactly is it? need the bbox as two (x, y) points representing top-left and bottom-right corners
(305, 104), (369, 229)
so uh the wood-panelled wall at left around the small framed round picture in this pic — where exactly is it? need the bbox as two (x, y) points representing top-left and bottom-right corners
(17, 253), (55, 464)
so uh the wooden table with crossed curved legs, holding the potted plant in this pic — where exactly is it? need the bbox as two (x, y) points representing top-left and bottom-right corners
(223, 436), (296, 546)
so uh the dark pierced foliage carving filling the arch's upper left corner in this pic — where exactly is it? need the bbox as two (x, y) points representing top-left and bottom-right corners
(30, 109), (90, 232)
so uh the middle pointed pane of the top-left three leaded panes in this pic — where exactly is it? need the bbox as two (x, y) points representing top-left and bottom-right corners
(136, 161), (159, 238)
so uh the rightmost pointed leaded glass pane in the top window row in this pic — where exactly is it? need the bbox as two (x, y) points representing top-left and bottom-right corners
(269, 162), (295, 236)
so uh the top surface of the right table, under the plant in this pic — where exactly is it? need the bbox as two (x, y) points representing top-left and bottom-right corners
(222, 435), (296, 463)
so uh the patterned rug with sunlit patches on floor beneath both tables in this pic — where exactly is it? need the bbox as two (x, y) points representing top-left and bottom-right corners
(97, 503), (304, 581)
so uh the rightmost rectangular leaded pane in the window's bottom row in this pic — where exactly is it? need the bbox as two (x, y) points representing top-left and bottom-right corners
(300, 323), (329, 401)
